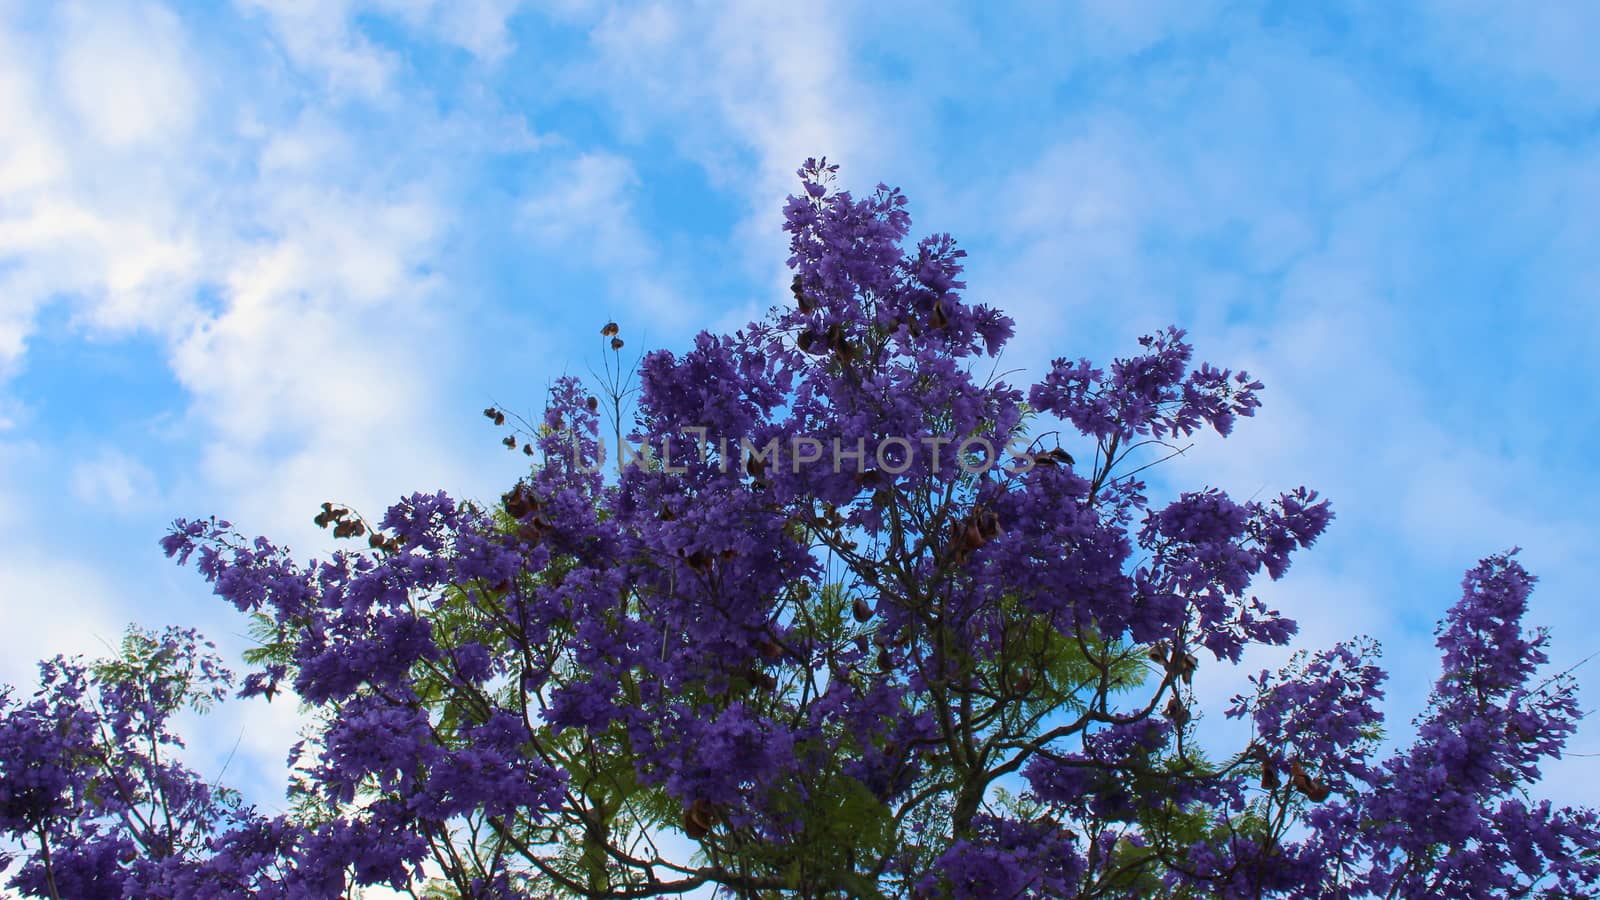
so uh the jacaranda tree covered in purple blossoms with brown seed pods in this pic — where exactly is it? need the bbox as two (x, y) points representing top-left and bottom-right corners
(0, 162), (1600, 898)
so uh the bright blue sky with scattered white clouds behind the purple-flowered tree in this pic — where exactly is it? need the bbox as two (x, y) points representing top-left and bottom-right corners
(0, 0), (1600, 806)
